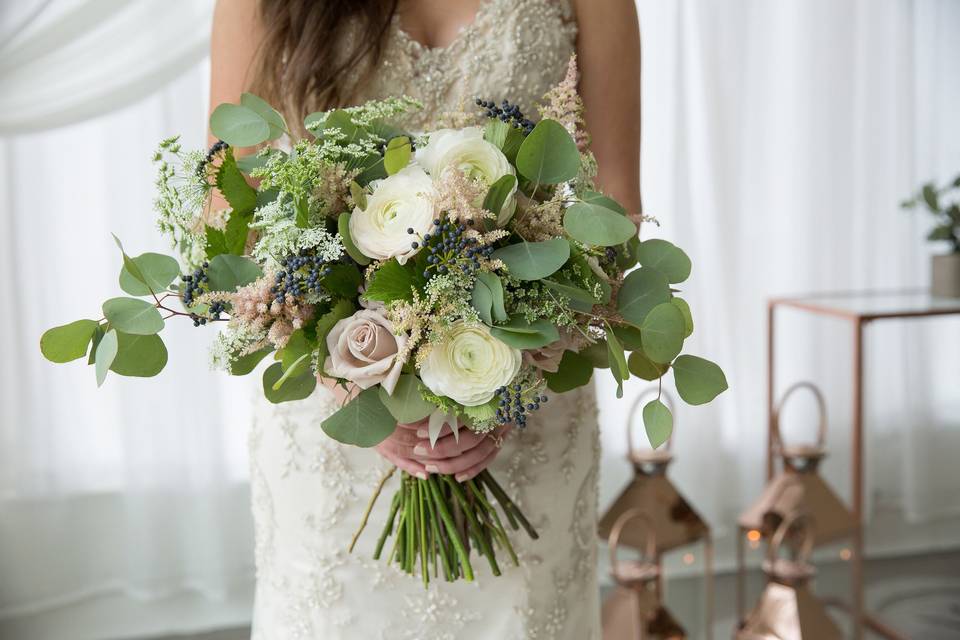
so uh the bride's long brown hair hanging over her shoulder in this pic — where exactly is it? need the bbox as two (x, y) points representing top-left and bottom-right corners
(250, 0), (398, 131)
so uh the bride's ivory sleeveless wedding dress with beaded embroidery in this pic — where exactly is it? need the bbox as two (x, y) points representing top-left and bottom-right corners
(250, 0), (600, 640)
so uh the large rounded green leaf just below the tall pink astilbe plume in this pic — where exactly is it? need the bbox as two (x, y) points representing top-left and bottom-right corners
(517, 120), (580, 184)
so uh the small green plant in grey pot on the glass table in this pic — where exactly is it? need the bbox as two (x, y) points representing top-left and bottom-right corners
(901, 175), (960, 298)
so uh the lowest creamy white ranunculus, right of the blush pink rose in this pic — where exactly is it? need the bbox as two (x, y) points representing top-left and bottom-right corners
(420, 321), (521, 407)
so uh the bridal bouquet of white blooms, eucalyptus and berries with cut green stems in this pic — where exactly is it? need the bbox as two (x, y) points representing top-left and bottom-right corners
(40, 62), (726, 583)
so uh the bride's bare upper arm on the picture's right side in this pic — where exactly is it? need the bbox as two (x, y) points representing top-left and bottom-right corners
(574, 0), (642, 220)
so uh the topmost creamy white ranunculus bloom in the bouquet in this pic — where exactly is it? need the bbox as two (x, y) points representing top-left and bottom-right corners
(416, 127), (517, 224)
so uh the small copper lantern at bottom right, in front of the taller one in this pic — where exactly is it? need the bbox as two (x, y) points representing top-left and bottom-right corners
(735, 514), (843, 640)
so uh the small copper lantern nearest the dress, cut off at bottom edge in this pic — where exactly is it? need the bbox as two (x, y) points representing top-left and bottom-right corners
(604, 509), (687, 640)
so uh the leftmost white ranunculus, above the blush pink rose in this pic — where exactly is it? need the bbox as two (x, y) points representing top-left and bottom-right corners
(350, 166), (436, 264)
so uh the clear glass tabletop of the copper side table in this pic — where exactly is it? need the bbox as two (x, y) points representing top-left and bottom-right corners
(771, 290), (960, 320)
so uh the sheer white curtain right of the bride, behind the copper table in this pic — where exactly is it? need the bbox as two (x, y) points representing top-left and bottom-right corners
(601, 0), (960, 564)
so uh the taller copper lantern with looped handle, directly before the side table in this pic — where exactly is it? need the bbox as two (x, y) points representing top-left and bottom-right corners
(737, 382), (858, 620)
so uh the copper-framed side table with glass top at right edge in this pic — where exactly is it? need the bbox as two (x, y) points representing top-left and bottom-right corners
(767, 290), (960, 640)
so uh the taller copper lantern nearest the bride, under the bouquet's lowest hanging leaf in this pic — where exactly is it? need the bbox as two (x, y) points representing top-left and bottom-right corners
(599, 389), (713, 640)
